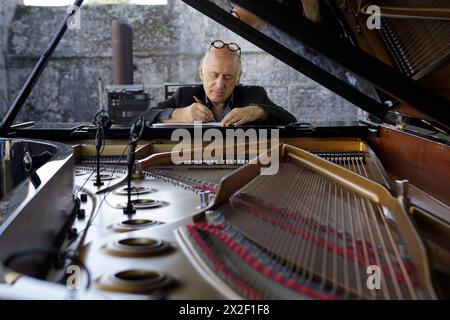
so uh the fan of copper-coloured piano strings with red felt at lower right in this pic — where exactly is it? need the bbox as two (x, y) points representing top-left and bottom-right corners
(191, 162), (421, 299)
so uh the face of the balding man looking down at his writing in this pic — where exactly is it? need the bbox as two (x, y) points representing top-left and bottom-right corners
(200, 48), (240, 103)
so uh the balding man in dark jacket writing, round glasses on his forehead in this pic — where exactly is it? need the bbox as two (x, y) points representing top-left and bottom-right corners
(147, 40), (296, 127)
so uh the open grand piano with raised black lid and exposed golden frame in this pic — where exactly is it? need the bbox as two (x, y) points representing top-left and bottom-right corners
(0, 0), (450, 300)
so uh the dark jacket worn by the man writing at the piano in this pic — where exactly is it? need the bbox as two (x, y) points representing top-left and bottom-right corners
(146, 85), (297, 125)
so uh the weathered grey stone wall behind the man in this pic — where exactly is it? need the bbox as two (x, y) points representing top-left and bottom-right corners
(0, 0), (358, 122)
